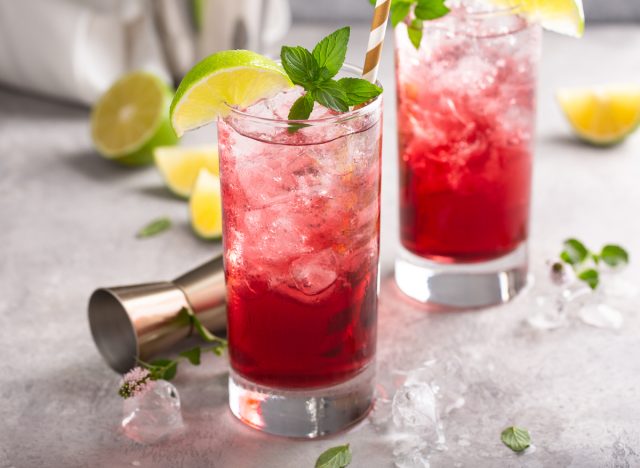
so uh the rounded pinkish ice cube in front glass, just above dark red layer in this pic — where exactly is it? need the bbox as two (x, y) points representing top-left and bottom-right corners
(289, 249), (338, 296)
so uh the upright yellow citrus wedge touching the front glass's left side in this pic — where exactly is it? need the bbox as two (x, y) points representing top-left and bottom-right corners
(189, 169), (222, 239)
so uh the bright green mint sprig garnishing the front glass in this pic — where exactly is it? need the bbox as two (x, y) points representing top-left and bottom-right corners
(280, 26), (382, 122)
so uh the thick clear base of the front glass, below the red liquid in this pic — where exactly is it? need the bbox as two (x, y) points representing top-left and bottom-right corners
(229, 362), (375, 438)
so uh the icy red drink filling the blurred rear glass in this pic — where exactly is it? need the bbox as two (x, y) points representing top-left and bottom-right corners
(396, 20), (538, 263)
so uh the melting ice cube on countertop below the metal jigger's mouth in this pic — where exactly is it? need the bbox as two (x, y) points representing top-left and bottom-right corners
(122, 380), (184, 444)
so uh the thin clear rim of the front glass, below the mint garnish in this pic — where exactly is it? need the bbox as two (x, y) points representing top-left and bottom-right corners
(223, 60), (384, 127)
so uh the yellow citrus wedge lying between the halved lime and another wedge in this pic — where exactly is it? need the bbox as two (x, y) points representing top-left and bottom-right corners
(153, 146), (219, 198)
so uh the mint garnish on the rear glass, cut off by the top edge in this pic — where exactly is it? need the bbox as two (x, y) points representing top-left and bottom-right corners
(369, 0), (450, 49)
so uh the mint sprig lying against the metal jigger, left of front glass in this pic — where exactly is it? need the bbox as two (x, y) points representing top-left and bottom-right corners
(138, 308), (228, 380)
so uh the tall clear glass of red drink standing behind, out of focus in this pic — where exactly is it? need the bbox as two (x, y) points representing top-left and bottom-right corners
(395, 4), (541, 308)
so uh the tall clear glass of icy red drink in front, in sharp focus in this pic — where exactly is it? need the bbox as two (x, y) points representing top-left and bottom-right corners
(218, 67), (382, 437)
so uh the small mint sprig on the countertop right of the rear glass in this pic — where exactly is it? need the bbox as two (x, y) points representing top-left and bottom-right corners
(560, 238), (629, 289)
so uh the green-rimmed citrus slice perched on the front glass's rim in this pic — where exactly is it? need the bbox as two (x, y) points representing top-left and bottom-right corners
(171, 50), (293, 136)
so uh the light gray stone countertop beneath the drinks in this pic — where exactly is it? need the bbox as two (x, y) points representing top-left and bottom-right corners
(0, 25), (640, 468)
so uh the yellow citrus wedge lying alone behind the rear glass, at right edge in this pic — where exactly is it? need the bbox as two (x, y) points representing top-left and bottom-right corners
(557, 85), (640, 145)
